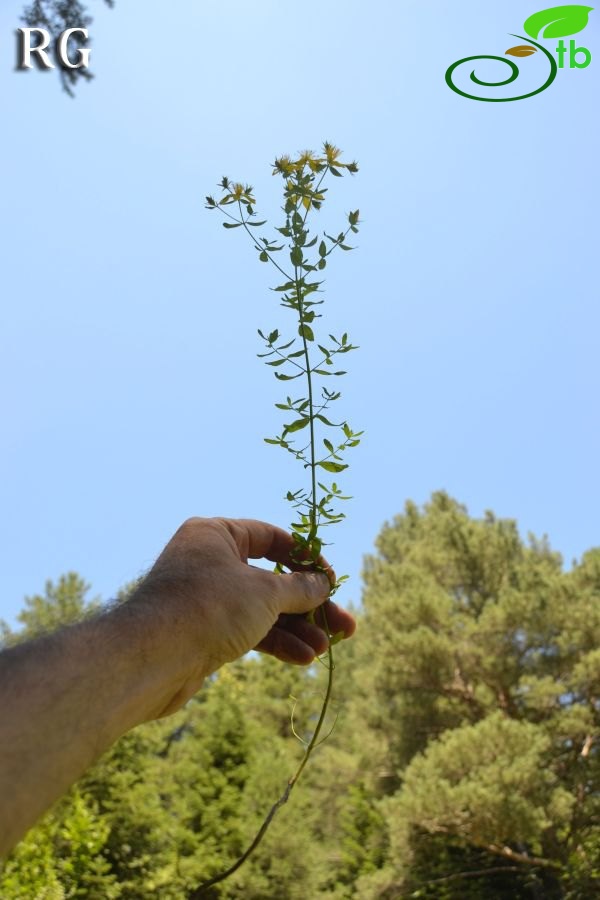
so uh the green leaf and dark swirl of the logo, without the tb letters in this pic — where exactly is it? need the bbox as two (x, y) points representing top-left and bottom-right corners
(446, 5), (593, 103)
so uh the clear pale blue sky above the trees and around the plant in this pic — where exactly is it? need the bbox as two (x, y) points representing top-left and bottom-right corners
(0, 0), (600, 623)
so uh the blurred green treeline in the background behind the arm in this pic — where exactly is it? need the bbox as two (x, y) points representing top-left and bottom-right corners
(0, 492), (600, 900)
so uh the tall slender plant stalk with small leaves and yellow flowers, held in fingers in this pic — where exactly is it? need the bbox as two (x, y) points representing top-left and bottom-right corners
(197, 143), (362, 900)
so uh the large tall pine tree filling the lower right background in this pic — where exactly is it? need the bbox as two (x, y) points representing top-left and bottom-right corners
(359, 493), (600, 897)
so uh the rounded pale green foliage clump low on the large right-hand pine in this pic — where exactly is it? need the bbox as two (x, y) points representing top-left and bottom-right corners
(395, 711), (574, 852)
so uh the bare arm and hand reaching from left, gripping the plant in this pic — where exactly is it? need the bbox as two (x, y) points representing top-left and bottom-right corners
(0, 518), (355, 857)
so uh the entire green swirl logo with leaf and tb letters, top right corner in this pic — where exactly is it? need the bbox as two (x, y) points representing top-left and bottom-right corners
(446, 5), (593, 103)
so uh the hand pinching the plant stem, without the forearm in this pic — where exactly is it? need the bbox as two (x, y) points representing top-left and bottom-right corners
(134, 518), (356, 715)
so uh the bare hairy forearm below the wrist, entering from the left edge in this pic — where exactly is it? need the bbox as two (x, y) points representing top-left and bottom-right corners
(0, 603), (202, 856)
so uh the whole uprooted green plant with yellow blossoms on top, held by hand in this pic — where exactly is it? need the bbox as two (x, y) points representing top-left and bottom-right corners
(191, 142), (362, 897)
